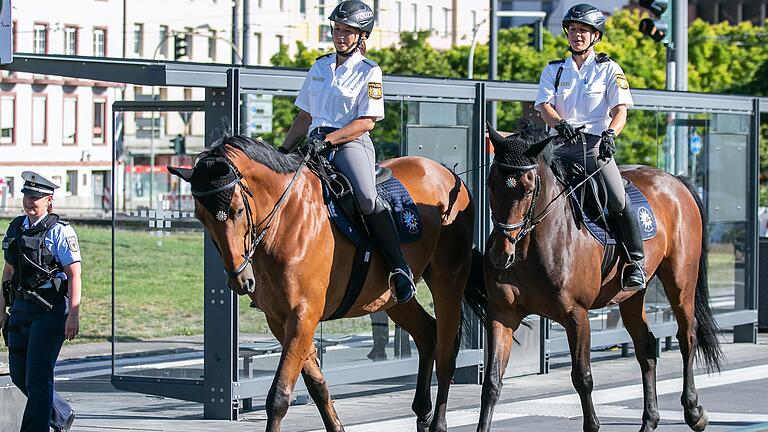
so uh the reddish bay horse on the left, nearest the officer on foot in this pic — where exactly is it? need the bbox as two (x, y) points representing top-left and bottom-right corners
(168, 135), (474, 432)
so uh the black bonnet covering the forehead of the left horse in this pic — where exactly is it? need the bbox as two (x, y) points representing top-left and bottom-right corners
(190, 156), (238, 221)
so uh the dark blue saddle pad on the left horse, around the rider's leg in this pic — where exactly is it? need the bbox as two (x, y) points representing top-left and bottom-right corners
(323, 177), (422, 245)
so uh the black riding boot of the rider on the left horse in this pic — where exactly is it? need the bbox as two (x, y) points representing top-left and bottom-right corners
(365, 198), (416, 303)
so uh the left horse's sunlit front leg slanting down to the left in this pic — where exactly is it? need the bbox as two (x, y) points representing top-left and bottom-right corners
(266, 316), (327, 432)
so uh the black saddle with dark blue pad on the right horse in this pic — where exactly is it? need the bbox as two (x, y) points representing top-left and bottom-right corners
(558, 159), (657, 278)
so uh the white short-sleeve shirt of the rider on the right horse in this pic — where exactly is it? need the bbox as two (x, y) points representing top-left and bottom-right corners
(534, 52), (634, 135)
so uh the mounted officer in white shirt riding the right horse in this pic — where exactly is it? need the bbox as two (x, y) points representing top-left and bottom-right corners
(535, 4), (646, 291)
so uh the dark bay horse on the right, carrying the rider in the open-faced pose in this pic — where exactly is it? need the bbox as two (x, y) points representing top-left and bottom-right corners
(466, 122), (723, 432)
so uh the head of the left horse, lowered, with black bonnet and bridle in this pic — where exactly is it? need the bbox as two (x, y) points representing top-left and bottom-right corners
(168, 136), (270, 295)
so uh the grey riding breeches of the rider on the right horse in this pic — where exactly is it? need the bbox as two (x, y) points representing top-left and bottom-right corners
(556, 134), (625, 213)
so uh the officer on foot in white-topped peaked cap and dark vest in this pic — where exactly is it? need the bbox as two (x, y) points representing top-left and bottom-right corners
(0, 171), (81, 432)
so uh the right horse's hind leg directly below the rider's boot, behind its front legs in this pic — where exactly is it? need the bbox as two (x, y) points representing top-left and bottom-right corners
(619, 291), (659, 432)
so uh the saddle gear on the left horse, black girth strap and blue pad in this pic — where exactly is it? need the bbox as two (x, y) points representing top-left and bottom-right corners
(307, 155), (422, 321)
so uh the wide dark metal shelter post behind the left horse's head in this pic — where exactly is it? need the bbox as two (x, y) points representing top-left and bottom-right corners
(203, 69), (240, 420)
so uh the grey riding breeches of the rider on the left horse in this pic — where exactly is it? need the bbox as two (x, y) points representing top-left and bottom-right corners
(331, 133), (378, 215)
